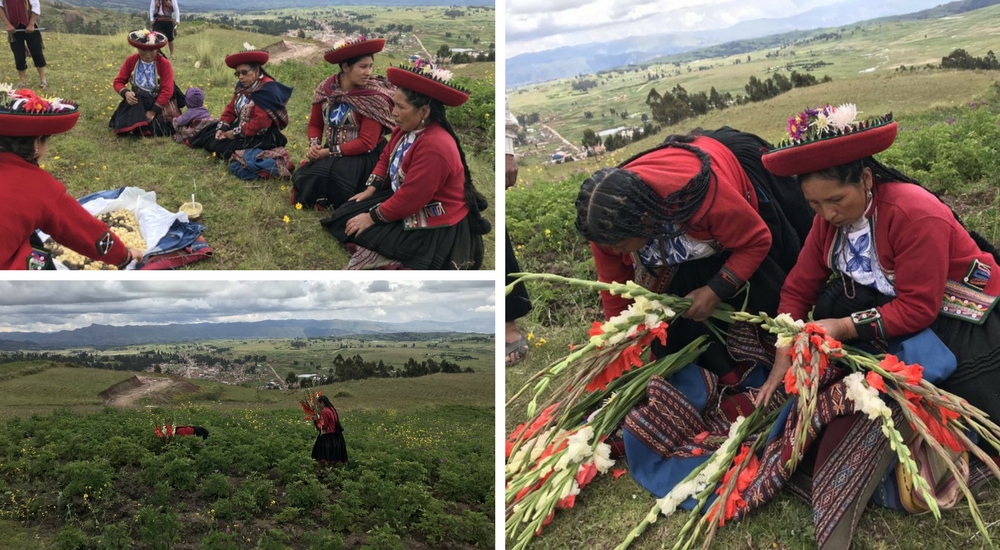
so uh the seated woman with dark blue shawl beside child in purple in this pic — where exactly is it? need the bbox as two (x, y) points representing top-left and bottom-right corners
(189, 49), (292, 160)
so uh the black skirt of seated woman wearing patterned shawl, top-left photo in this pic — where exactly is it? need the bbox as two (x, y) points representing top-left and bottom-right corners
(292, 139), (385, 208)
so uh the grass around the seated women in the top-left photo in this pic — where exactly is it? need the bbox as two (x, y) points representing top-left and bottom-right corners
(17, 17), (495, 269)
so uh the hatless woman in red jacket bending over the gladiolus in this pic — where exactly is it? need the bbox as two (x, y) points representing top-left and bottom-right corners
(576, 127), (810, 375)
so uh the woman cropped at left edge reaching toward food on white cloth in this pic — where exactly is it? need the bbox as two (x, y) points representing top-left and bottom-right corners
(0, 85), (142, 269)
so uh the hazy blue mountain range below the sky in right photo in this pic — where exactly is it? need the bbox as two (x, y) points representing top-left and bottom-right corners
(506, 0), (1000, 88)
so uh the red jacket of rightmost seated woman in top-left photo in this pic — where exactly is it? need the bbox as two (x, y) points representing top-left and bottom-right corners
(372, 123), (469, 227)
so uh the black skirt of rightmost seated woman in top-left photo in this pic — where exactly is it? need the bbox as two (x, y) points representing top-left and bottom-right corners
(320, 190), (483, 269)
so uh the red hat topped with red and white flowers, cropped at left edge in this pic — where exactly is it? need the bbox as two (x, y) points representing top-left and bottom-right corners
(0, 84), (80, 137)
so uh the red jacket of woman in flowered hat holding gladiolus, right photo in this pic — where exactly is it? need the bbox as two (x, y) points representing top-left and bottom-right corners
(778, 182), (1000, 340)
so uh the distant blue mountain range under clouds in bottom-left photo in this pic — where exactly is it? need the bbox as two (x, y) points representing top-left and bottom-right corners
(0, 319), (495, 350)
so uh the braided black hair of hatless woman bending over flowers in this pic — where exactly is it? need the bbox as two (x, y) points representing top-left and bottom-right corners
(576, 133), (718, 244)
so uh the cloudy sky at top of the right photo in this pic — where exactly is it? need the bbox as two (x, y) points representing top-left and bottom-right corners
(505, 0), (946, 58)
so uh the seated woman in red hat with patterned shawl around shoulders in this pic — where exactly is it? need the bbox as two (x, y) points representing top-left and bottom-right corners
(292, 37), (394, 208)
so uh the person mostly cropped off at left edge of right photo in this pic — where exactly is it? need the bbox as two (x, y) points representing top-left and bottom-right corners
(504, 96), (531, 367)
